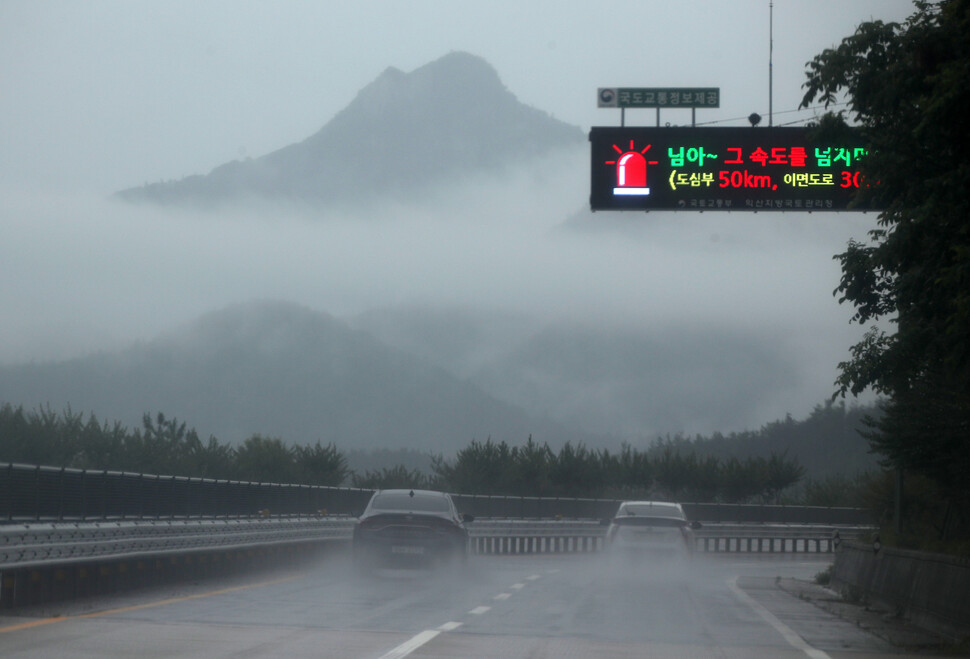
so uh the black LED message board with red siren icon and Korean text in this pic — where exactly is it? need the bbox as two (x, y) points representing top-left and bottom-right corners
(589, 127), (871, 211)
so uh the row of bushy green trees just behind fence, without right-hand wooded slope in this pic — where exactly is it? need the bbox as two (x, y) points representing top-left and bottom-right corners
(0, 405), (804, 502)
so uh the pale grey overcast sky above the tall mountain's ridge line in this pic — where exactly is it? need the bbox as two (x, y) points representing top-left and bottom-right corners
(0, 0), (912, 194)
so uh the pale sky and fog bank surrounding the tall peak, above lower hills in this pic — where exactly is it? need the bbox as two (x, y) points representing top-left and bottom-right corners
(0, 0), (912, 440)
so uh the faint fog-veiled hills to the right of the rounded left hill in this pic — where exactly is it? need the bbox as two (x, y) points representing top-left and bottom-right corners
(352, 308), (797, 440)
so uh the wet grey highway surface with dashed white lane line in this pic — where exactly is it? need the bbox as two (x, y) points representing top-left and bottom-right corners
(0, 555), (932, 659)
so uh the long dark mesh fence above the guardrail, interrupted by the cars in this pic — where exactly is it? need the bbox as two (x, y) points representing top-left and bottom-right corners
(0, 463), (870, 526)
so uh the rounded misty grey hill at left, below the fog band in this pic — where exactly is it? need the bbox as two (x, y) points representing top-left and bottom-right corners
(0, 301), (562, 451)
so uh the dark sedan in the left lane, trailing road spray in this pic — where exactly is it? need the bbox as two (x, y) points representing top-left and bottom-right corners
(353, 490), (472, 568)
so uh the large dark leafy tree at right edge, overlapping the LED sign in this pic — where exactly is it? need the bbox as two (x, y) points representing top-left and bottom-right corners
(803, 0), (970, 511)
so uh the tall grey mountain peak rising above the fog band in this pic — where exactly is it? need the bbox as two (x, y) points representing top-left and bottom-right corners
(118, 52), (584, 205)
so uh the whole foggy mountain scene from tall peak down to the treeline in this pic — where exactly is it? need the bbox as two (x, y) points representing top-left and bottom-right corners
(0, 53), (874, 451)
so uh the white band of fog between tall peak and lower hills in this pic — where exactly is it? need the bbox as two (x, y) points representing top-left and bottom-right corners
(0, 149), (876, 432)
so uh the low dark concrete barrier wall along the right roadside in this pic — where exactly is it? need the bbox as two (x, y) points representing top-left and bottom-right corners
(832, 542), (970, 642)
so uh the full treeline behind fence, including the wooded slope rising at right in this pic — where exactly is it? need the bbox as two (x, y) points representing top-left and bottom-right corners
(0, 403), (875, 506)
